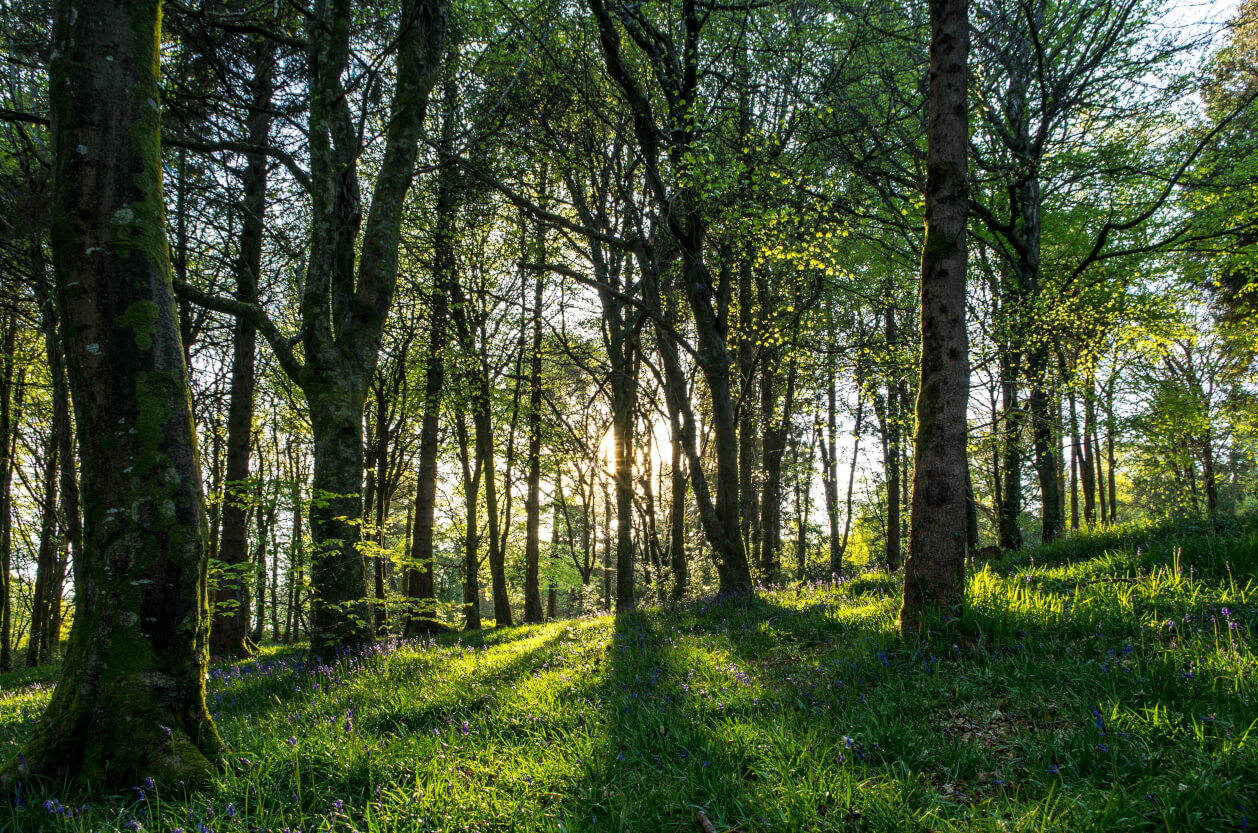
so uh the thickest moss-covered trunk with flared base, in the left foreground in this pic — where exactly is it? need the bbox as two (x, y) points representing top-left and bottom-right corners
(4, 0), (221, 788)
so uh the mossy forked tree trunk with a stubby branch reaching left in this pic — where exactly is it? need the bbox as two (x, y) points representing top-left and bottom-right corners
(180, 0), (447, 653)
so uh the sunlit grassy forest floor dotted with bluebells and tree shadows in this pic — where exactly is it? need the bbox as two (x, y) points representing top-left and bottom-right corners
(0, 522), (1258, 833)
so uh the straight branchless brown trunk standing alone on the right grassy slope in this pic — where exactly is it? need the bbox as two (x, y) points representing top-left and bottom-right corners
(899, 0), (970, 634)
